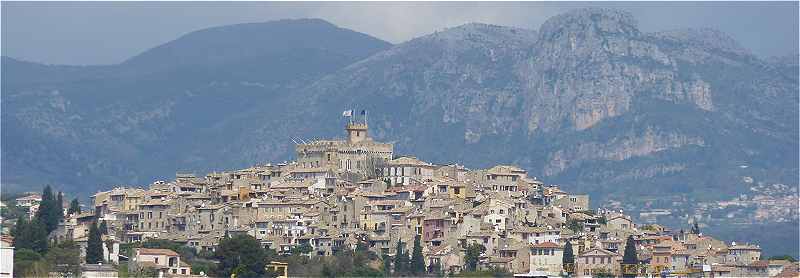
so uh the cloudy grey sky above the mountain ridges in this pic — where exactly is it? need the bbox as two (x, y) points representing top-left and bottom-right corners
(0, 1), (799, 65)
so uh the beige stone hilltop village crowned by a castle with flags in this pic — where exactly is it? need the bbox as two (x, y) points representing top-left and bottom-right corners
(3, 118), (797, 277)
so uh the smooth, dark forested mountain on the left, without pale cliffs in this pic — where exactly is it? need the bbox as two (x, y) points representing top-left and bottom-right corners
(2, 19), (391, 193)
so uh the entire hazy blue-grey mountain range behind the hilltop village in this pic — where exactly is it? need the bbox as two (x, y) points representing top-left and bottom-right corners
(2, 9), (800, 253)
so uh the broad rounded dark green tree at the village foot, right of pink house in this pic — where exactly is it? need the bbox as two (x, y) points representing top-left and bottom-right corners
(215, 235), (266, 277)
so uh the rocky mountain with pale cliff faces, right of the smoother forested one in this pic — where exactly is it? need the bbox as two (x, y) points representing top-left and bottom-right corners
(234, 9), (798, 204)
